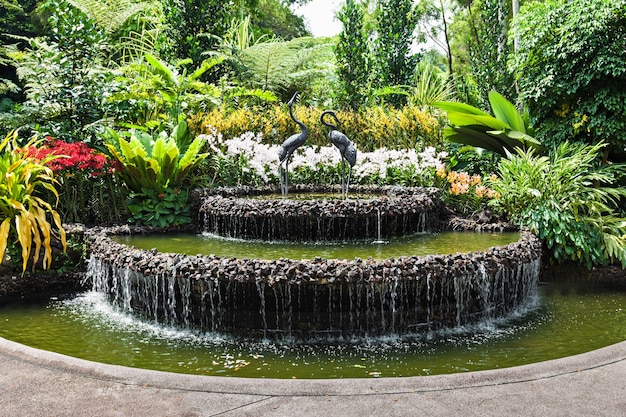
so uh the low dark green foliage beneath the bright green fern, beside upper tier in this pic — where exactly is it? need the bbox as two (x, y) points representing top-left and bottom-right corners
(128, 188), (191, 227)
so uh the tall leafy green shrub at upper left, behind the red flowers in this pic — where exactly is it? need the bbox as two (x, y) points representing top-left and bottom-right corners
(3, 0), (109, 142)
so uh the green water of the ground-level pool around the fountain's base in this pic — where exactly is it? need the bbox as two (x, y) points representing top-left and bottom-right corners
(0, 282), (626, 378)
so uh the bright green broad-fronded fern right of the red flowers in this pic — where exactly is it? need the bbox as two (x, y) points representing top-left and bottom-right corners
(106, 121), (207, 194)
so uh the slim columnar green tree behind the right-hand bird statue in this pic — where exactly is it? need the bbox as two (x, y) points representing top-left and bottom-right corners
(335, 0), (370, 110)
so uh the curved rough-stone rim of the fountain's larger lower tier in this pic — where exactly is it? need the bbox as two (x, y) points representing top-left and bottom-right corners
(86, 226), (541, 285)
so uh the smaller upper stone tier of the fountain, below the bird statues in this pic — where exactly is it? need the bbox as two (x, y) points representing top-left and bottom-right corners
(192, 185), (451, 242)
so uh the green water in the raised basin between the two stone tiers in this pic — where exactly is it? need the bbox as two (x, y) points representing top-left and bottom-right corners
(115, 232), (520, 260)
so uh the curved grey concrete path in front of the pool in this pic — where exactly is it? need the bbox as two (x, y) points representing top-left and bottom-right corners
(0, 338), (626, 417)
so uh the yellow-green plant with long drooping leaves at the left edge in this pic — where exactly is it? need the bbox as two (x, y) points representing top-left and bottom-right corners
(0, 131), (66, 271)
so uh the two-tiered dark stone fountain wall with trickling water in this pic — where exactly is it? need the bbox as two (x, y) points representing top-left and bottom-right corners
(89, 187), (541, 338)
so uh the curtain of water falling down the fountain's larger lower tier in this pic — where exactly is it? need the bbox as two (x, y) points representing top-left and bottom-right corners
(87, 232), (540, 337)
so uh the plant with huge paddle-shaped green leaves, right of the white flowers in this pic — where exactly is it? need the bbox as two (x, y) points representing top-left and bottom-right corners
(434, 91), (543, 156)
